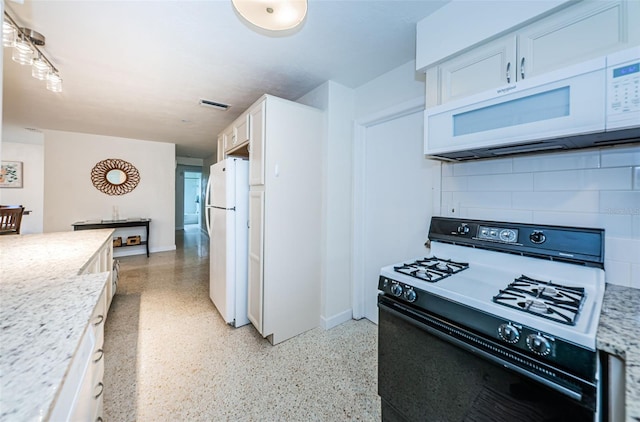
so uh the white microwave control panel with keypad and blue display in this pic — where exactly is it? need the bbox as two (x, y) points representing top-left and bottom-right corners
(607, 48), (640, 127)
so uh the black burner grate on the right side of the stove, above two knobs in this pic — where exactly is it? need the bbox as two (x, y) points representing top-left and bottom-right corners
(493, 275), (586, 325)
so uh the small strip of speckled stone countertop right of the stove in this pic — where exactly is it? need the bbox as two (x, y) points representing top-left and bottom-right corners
(596, 284), (640, 422)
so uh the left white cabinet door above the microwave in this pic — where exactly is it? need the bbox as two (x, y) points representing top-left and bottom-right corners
(438, 35), (516, 104)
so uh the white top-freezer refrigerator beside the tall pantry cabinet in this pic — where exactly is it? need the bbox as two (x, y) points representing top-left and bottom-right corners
(205, 158), (249, 327)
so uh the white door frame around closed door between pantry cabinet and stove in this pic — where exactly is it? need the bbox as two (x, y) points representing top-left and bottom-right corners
(351, 96), (425, 319)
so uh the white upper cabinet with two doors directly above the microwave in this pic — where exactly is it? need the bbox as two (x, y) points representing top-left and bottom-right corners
(426, 0), (640, 107)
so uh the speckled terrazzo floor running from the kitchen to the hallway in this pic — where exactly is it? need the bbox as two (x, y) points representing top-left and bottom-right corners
(104, 226), (380, 422)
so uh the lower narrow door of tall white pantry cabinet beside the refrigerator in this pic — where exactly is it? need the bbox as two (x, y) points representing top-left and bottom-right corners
(247, 190), (264, 334)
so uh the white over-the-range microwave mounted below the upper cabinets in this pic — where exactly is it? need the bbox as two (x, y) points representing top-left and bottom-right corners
(424, 46), (640, 161)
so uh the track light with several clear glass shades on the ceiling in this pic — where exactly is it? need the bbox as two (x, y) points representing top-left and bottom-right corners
(2, 10), (62, 92)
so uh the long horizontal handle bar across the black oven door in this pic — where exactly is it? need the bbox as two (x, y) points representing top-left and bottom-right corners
(378, 301), (582, 401)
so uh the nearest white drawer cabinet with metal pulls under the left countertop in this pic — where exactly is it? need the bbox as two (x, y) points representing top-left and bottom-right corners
(49, 286), (107, 422)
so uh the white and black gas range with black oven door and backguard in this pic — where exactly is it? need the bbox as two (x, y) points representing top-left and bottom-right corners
(378, 217), (605, 420)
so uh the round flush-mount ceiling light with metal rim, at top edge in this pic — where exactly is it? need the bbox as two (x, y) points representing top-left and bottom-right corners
(231, 0), (307, 31)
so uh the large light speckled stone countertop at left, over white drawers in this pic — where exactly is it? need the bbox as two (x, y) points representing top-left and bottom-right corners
(0, 229), (113, 422)
